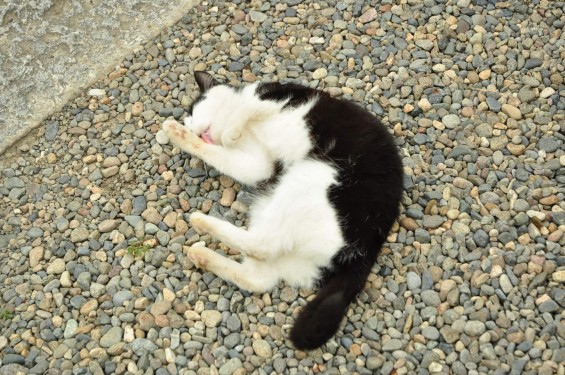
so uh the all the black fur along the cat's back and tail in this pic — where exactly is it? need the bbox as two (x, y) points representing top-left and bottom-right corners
(257, 83), (403, 350)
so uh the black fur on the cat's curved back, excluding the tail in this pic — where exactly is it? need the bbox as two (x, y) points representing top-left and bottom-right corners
(258, 84), (403, 253)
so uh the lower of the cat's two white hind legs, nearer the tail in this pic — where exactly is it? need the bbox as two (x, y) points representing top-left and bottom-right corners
(188, 246), (278, 293)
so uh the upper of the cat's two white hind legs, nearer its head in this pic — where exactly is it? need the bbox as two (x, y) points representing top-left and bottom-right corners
(190, 212), (267, 260)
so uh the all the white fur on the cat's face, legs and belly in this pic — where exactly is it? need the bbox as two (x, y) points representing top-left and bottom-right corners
(163, 85), (345, 292)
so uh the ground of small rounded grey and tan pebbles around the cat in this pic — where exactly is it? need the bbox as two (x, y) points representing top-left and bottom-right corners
(0, 0), (565, 375)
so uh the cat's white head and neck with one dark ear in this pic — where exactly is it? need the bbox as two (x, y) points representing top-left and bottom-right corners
(185, 72), (284, 147)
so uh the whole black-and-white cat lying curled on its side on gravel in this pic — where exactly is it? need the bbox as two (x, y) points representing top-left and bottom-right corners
(163, 72), (402, 350)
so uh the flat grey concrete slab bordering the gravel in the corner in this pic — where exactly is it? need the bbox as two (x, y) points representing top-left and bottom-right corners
(0, 0), (198, 154)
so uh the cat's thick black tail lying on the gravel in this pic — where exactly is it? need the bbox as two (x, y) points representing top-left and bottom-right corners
(290, 262), (372, 350)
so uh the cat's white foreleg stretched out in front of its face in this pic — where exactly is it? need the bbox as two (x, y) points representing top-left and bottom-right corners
(163, 120), (274, 185)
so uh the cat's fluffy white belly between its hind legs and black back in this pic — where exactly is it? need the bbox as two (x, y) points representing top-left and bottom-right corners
(249, 159), (344, 287)
